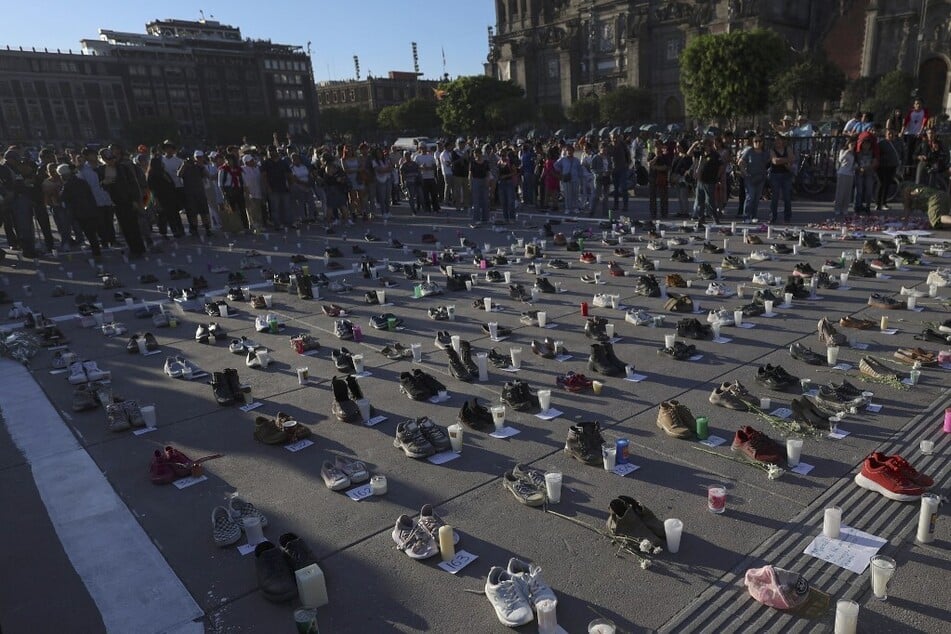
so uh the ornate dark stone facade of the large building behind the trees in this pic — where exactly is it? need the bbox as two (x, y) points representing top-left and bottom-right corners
(486, 0), (951, 122)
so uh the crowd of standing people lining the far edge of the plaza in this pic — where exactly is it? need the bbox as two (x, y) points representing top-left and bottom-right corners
(0, 100), (949, 259)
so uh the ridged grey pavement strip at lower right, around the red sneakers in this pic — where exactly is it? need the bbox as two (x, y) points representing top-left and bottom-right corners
(660, 391), (951, 632)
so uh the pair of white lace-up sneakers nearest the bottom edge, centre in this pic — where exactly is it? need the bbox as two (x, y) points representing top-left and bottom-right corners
(485, 557), (557, 627)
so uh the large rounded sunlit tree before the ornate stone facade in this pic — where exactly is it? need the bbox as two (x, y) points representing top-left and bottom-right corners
(680, 29), (789, 120)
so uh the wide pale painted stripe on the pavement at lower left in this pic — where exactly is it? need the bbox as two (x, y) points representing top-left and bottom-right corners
(0, 360), (203, 632)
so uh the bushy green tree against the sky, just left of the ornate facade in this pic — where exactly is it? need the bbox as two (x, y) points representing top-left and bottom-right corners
(436, 75), (524, 134)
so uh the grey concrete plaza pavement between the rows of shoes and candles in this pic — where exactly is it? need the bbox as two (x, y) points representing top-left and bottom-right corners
(0, 194), (951, 633)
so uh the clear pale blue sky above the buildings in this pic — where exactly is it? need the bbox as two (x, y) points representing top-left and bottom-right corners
(0, 0), (495, 82)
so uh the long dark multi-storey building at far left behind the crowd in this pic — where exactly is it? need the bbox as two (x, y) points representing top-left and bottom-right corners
(0, 20), (317, 145)
